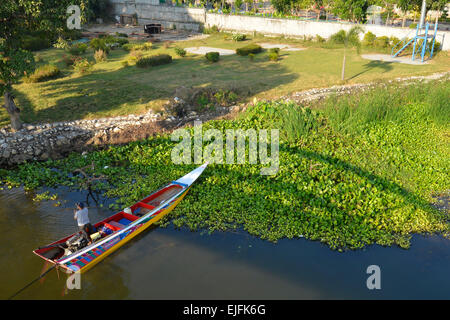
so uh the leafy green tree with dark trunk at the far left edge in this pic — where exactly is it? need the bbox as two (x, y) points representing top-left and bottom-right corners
(0, 0), (87, 130)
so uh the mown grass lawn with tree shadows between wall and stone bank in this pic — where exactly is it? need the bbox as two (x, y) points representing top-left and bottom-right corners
(4, 33), (450, 125)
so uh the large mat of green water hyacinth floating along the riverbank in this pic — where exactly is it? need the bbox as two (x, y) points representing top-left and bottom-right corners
(0, 81), (450, 250)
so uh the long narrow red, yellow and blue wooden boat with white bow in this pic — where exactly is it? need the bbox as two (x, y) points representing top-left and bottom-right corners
(33, 163), (208, 273)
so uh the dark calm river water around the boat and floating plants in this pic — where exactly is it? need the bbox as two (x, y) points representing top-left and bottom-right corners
(0, 189), (450, 299)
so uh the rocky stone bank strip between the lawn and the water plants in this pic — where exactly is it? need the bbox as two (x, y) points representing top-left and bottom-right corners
(0, 72), (450, 166)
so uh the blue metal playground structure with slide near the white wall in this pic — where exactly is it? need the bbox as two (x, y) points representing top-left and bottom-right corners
(391, 22), (438, 62)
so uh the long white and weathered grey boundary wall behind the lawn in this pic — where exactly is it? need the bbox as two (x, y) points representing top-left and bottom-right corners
(111, 0), (450, 50)
